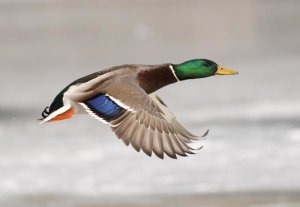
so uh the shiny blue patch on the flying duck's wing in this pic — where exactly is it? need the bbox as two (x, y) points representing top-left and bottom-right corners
(85, 94), (123, 119)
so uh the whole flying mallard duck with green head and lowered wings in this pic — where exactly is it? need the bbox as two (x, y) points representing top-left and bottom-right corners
(41, 59), (237, 159)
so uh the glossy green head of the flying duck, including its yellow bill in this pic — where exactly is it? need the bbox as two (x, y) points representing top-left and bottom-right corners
(172, 59), (237, 80)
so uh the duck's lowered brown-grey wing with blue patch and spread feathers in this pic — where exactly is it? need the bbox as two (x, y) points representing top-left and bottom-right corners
(81, 83), (208, 159)
